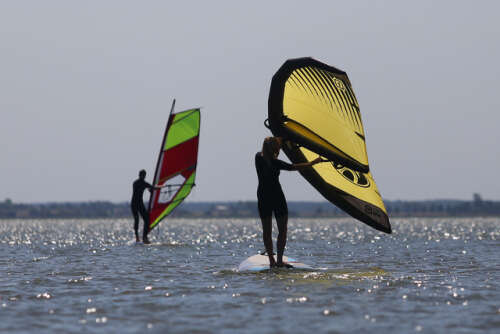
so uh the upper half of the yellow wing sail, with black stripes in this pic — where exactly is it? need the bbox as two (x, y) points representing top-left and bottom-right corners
(269, 58), (369, 173)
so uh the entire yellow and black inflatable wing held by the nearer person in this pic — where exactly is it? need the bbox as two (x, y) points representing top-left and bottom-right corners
(268, 58), (391, 233)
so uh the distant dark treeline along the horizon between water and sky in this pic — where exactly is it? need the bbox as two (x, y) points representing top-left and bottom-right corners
(0, 194), (500, 218)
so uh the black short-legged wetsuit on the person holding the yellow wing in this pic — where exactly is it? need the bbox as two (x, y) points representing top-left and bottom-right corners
(255, 152), (293, 218)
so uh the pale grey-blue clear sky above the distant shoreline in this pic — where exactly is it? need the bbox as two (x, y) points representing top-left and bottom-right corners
(0, 0), (500, 203)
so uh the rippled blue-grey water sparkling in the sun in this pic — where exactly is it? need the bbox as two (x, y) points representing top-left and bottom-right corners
(0, 218), (500, 333)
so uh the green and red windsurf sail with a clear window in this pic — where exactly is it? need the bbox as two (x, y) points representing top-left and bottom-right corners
(149, 100), (200, 230)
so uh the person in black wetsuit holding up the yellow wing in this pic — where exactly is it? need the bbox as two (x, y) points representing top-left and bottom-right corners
(255, 137), (326, 268)
